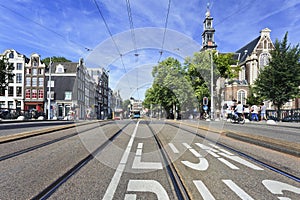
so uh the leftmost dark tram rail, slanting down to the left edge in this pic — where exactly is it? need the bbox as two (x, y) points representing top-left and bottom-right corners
(0, 123), (110, 162)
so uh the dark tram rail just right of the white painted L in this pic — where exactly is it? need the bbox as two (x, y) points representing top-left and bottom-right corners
(146, 123), (191, 200)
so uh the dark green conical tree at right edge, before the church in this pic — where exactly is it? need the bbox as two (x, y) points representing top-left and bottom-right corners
(254, 32), (300, 116)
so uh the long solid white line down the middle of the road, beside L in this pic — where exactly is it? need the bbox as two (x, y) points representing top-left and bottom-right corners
(103, 121), (140, 200)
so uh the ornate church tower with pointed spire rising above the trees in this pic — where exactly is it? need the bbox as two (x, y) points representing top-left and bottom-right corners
(202, 4), (217, 51)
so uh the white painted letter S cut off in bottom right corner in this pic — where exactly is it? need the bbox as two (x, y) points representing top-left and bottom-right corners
(262, 180), (300, 198)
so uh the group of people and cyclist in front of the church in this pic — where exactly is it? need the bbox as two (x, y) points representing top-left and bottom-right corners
(222, 101), (267, 121)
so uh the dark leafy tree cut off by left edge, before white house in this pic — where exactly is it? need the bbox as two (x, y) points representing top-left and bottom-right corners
(0, 57), (15, 92)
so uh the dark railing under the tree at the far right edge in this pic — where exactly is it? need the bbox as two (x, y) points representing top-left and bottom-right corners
(266, 109), (300, 122)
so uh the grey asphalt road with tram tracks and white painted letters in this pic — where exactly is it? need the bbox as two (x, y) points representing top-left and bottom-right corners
(0, 120), (300, 200)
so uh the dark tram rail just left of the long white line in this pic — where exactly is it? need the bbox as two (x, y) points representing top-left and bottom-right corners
(32, 122), (131, 200)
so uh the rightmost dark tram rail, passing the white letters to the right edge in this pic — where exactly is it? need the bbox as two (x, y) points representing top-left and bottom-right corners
(167, 123), (300, 182)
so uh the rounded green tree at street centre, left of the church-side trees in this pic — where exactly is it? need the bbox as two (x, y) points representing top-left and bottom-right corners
(144, 57), (195, 118)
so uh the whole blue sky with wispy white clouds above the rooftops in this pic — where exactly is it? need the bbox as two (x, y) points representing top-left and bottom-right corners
(0, 0), (300, 99)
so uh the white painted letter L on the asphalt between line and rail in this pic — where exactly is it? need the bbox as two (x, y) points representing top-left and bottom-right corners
(132, 143), (163, 169)
